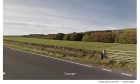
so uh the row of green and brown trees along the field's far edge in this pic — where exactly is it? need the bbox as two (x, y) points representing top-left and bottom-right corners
(23, 30), (137, 44)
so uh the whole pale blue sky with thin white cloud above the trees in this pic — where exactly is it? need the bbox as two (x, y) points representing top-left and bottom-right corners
(3, 0), (137, 35)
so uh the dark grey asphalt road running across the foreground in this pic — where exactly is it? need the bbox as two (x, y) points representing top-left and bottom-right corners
(3, 47), (136, 80)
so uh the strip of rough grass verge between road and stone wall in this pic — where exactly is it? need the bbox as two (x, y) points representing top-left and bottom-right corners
(4, 39), (136, 74)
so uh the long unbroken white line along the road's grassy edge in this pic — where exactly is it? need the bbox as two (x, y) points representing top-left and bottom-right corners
(4, 46), (92, 67)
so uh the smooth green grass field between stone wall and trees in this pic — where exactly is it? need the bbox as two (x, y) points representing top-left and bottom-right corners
(4, 37), (136, 51)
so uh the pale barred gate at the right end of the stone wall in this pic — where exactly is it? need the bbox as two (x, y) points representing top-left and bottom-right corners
(106, 49), (137, 63)
